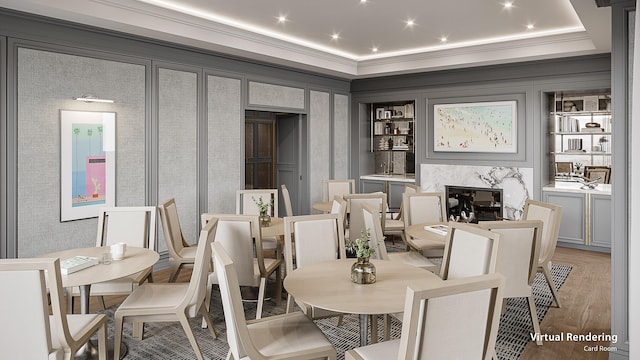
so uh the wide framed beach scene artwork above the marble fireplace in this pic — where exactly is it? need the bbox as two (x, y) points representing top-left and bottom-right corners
(433, 100), (518, 153)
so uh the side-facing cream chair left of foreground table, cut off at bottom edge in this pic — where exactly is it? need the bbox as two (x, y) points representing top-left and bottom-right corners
(213, 242), (336, 360)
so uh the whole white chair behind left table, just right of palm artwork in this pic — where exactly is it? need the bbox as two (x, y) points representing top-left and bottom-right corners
(67, 206), (157, 312)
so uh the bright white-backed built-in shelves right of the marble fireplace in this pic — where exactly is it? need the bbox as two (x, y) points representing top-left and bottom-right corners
(549, 94), (612, 170)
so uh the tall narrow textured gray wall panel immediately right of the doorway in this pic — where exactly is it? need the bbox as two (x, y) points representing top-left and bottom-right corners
(308, 90), (331, 211)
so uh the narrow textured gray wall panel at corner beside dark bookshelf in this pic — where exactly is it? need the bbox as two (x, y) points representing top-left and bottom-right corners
(332, 94), (350, 179)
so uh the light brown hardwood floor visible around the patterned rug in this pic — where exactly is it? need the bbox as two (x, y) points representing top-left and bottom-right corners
(91, 243), (611, 360)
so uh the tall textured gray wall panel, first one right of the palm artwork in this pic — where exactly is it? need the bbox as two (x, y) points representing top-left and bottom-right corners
(157, 68), (200, 251)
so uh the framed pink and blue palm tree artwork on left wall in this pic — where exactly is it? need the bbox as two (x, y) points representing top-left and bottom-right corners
(60, 110), (116, 221)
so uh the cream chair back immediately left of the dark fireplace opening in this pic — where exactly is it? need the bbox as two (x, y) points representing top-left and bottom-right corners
(402, 192), (447, 228)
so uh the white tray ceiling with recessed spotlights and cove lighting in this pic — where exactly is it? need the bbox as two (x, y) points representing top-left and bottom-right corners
(0, 0), (611, 79)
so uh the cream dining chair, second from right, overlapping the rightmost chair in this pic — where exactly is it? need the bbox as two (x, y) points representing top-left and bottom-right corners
(478, 220), (543, 345)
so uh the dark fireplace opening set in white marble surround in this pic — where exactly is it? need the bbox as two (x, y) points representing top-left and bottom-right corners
(445, 185), (503, 223)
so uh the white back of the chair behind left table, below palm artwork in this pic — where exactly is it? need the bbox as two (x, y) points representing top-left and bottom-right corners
(96, 206), (156, 250)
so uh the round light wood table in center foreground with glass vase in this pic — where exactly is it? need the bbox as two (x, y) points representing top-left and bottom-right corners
(284, 259), (442, 346)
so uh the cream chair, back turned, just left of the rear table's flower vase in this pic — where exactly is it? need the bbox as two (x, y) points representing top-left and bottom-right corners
(201, 214), (282, 319)
